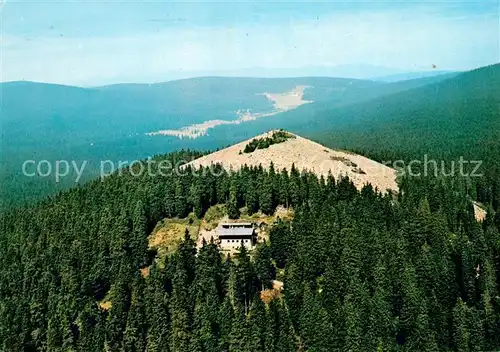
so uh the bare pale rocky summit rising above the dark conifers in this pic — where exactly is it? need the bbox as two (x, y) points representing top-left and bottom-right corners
(184, 131), (398, 191)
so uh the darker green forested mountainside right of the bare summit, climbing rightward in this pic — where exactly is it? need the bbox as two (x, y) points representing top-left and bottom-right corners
(230, 64), (500, 203)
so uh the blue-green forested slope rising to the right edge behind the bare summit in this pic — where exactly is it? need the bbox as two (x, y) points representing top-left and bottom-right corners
(237, 65), (500, 152)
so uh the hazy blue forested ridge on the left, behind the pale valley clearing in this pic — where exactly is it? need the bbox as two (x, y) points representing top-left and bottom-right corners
(0, 77), (382, 203)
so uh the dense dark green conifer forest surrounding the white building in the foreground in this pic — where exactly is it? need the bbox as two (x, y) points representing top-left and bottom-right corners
(0, 152), (500, 352)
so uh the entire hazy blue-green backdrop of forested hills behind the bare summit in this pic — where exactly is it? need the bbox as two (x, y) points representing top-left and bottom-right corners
(0, 65), (500, 208)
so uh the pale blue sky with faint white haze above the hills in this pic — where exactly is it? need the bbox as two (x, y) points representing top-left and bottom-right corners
(0, 0), (500, 85)
